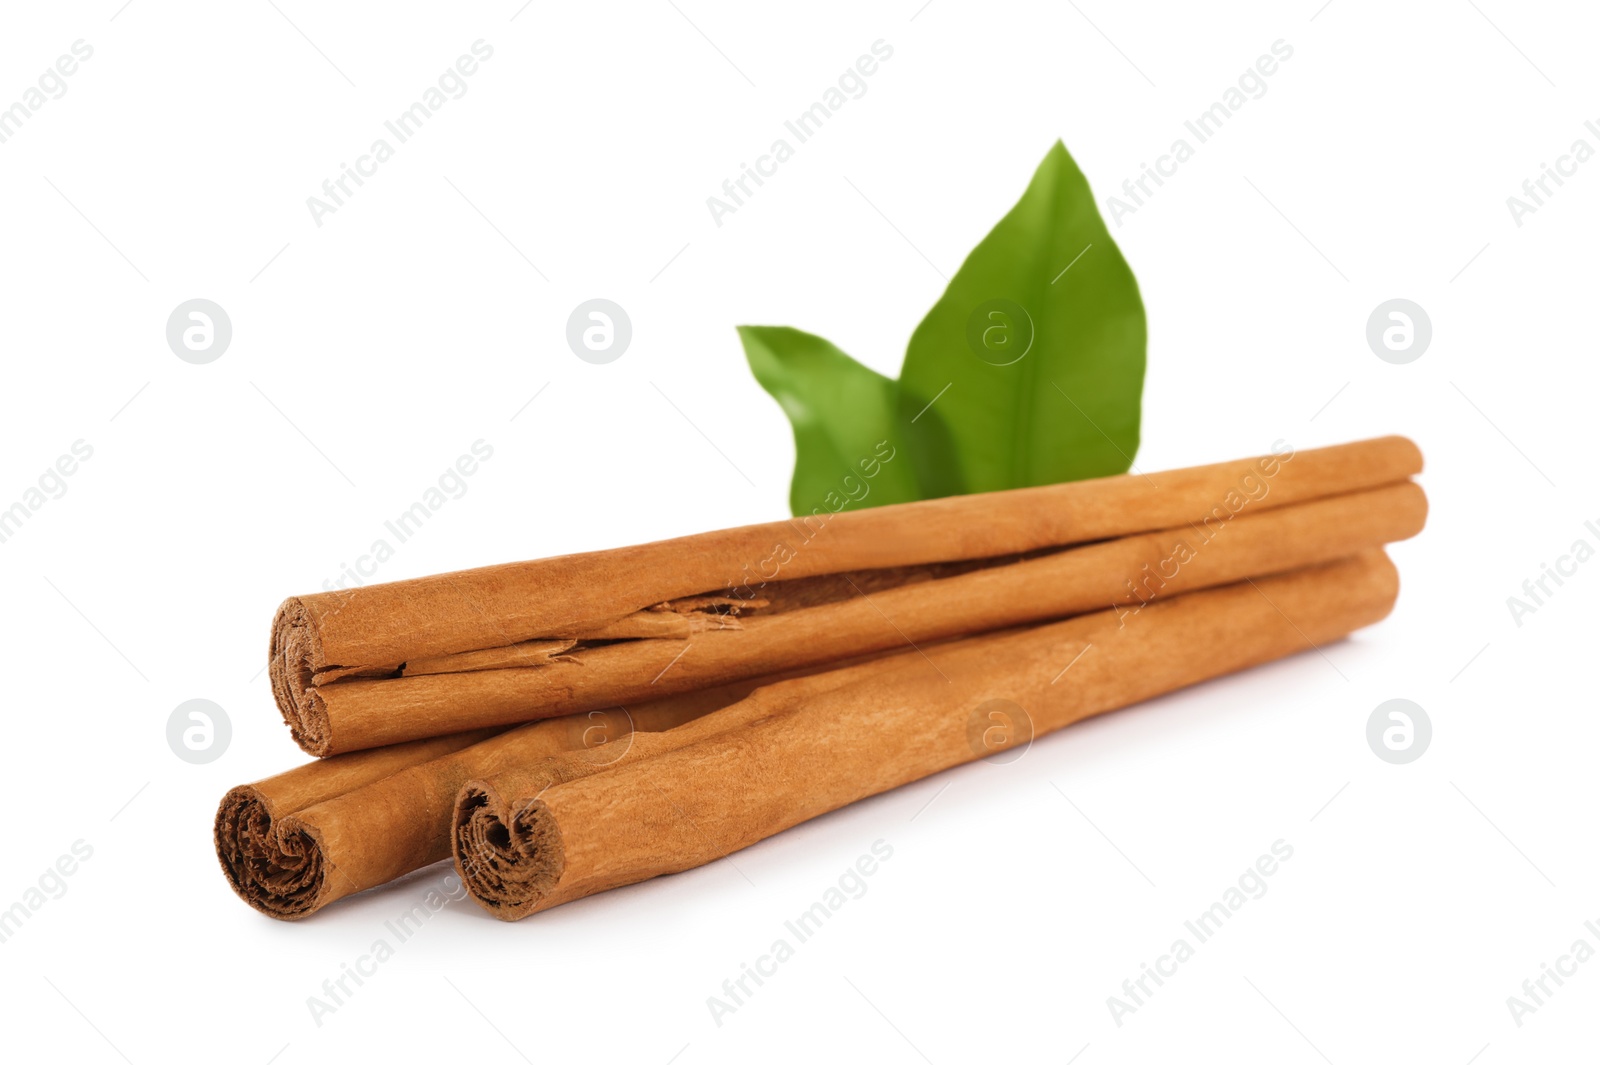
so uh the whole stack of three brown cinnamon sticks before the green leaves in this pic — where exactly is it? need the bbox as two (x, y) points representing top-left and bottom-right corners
(214, 437), (1427, 919)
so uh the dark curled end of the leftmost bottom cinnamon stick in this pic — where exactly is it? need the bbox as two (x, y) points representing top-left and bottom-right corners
(213, 785), (328, 921)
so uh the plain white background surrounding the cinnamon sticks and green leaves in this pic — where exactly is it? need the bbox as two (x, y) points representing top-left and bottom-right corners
(0, 0), (1600, 1065)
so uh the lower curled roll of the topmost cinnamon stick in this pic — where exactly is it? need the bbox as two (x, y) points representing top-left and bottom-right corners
(278, 463), (1427, 753)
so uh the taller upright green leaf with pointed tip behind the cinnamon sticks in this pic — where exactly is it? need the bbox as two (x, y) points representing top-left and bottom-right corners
(899, 141), (1146, 497)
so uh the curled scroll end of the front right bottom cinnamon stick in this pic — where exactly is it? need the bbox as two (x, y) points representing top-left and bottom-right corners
(450, 780), (566, 921)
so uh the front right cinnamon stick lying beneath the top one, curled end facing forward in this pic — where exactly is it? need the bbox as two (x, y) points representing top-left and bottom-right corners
(451, 550), (1398, 919)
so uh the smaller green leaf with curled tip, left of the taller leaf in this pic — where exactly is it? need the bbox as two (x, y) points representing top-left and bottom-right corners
(739, 326), (922, 515)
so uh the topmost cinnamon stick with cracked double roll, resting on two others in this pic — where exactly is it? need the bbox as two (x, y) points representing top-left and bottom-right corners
(270, 437), (1426, 755)
